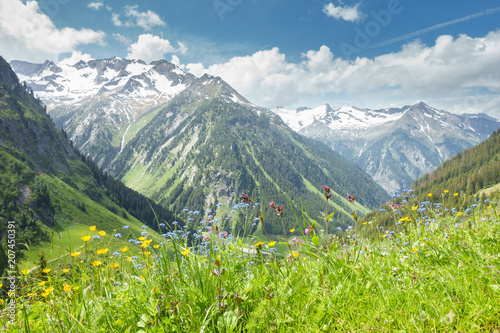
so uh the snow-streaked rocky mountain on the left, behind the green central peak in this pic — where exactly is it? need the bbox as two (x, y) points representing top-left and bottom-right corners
(11, 57), (251, 168)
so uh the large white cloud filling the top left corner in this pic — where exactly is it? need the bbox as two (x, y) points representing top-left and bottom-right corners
(0, 0), (105, 61)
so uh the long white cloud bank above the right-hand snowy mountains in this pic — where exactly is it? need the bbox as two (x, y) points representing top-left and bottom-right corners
(186, 31), (500, 115)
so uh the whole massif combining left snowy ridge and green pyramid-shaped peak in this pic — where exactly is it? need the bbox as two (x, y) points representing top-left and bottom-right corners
(11, 58), (388, 234)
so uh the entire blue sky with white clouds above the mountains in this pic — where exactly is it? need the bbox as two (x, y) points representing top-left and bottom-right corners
(0, 0), (500, 116)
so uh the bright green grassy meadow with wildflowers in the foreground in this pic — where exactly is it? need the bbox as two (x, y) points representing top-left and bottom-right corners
(0, 191), (500, 332)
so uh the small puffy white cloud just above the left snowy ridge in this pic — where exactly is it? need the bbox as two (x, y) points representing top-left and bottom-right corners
(127, 34), (175, 63)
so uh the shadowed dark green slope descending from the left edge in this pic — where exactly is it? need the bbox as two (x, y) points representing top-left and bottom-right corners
(0, 57), (179, 276)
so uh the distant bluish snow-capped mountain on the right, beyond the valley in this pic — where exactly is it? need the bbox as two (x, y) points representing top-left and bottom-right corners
(272, 103), (500, 193)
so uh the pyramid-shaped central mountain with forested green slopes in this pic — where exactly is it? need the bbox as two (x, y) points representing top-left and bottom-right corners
(109, 76), (387, 234)
